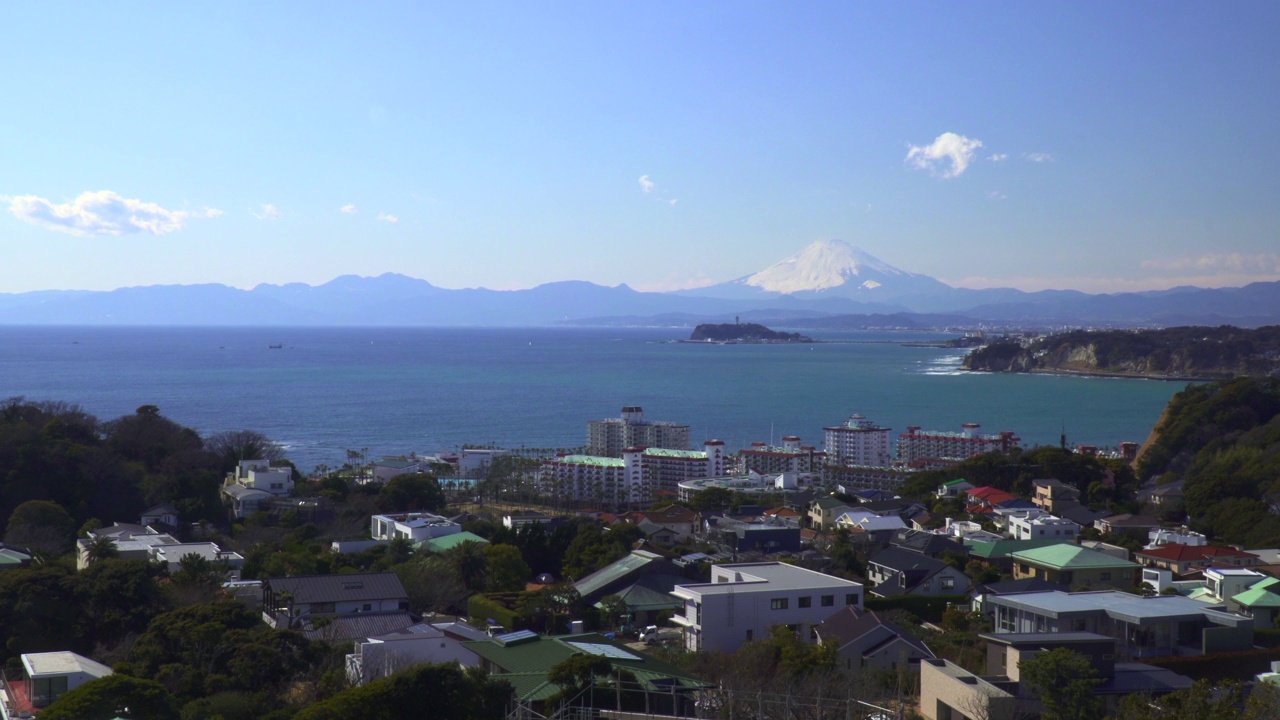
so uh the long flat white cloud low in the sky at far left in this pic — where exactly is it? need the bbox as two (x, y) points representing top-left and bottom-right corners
(6, 190), (223, 237)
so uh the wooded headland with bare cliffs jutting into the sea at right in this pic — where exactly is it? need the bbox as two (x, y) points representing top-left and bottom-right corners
(964, 325), (1280, 379)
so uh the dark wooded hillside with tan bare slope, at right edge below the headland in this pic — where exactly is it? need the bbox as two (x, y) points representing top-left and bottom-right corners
(1138, 378), (1280, 547)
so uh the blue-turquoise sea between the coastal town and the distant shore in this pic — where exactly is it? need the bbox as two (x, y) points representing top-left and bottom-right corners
(0, 327), (1184, 470)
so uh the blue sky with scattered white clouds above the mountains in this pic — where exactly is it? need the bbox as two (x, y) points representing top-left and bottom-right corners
(0, 1), (1280, 292)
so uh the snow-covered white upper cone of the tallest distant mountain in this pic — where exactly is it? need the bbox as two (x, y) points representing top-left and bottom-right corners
(742, 240), (913, 295)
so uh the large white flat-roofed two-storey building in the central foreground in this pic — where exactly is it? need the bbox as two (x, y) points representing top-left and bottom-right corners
(671, 562), (863, 652)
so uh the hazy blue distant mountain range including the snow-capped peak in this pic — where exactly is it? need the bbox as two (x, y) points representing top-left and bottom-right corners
(0, 240), (1280, 329)
